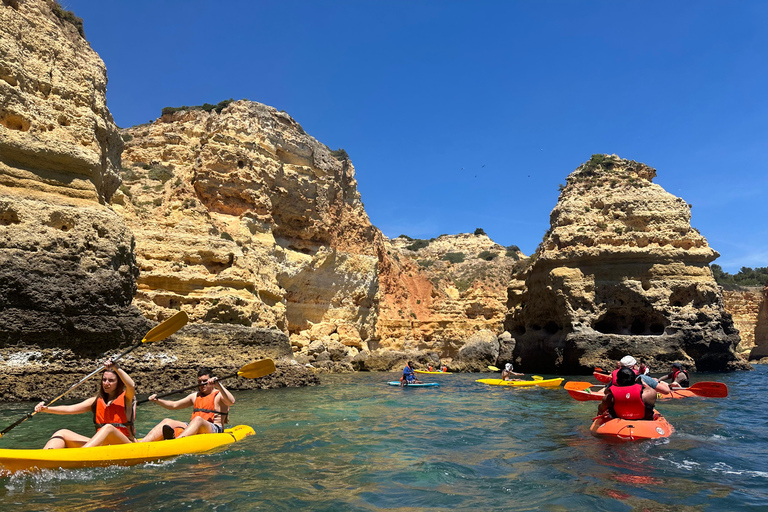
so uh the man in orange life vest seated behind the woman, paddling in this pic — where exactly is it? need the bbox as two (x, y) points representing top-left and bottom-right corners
(141, 368), (235, 442)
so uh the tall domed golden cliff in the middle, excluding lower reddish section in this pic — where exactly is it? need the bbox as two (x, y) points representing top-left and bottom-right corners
(118, 101), (382, 344)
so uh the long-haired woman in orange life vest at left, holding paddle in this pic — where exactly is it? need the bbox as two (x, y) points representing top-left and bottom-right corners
(35, 360), (136, 449)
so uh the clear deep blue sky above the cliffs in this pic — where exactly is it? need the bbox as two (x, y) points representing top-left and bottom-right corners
(60, 0), (768, 273)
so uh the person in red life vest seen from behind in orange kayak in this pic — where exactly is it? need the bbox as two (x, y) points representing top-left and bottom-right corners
(597, 367), (670, 420)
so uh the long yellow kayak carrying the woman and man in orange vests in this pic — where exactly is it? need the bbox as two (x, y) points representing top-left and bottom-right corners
(0, 425), (255, 474)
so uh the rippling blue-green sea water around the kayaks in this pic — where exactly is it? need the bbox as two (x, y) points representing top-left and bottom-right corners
(0, 366), (768, 512)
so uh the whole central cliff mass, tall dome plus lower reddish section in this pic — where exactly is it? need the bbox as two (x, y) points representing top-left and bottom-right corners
(113, 104), (522, 371)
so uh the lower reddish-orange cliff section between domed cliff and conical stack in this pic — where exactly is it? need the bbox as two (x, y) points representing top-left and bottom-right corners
(370, 232), (524, 358)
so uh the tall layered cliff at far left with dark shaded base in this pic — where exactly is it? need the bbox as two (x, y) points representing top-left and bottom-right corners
(0, 0), (149, 356)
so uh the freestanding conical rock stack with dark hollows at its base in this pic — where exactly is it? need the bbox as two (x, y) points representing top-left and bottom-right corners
(505, 155), (746, 373)
